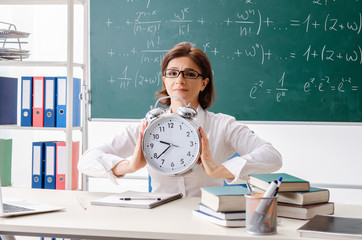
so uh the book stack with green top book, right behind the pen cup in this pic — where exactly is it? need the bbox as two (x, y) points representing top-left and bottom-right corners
(250, 173), (334, 220)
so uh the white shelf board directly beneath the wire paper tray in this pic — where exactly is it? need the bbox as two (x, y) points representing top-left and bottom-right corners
(0, 60), (85, 68)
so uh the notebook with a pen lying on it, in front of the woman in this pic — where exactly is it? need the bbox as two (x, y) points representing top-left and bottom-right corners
(91, 191), (182, 208)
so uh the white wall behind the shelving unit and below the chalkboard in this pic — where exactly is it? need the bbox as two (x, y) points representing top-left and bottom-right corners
(0, 5), (362, 203)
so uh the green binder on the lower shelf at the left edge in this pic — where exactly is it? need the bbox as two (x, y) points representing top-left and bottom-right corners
(0, 139), (12, 186)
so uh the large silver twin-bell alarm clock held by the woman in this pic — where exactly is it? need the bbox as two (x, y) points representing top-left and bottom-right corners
(142, 96), (200, 176)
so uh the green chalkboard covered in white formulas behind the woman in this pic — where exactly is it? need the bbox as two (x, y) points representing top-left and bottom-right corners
(90, 0), (362, 123)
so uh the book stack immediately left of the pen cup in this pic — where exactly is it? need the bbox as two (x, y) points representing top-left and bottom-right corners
(193, 186), (250, 227)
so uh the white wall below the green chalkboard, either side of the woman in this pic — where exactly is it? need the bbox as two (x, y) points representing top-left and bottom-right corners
(85, 122), (362, 203)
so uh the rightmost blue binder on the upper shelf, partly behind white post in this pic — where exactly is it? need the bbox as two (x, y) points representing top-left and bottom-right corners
(56, 77), (81, 127)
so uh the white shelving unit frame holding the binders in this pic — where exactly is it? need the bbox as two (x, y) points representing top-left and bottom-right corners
(0, 0), (89, 189)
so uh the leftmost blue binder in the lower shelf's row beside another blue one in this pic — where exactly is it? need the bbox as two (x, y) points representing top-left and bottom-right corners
(31, 142), (44, 188)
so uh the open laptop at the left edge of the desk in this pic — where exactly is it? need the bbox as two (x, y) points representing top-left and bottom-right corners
(0, 183), (64, 217)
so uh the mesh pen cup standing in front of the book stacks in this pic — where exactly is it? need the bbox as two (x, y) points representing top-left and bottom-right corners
(245, 194), (278, 235)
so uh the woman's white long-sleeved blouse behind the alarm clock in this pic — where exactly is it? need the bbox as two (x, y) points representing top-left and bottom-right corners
(78, 107), (282, 196)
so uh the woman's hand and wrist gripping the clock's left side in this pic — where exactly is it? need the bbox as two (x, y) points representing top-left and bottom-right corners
(112, 122), (148, 177)
